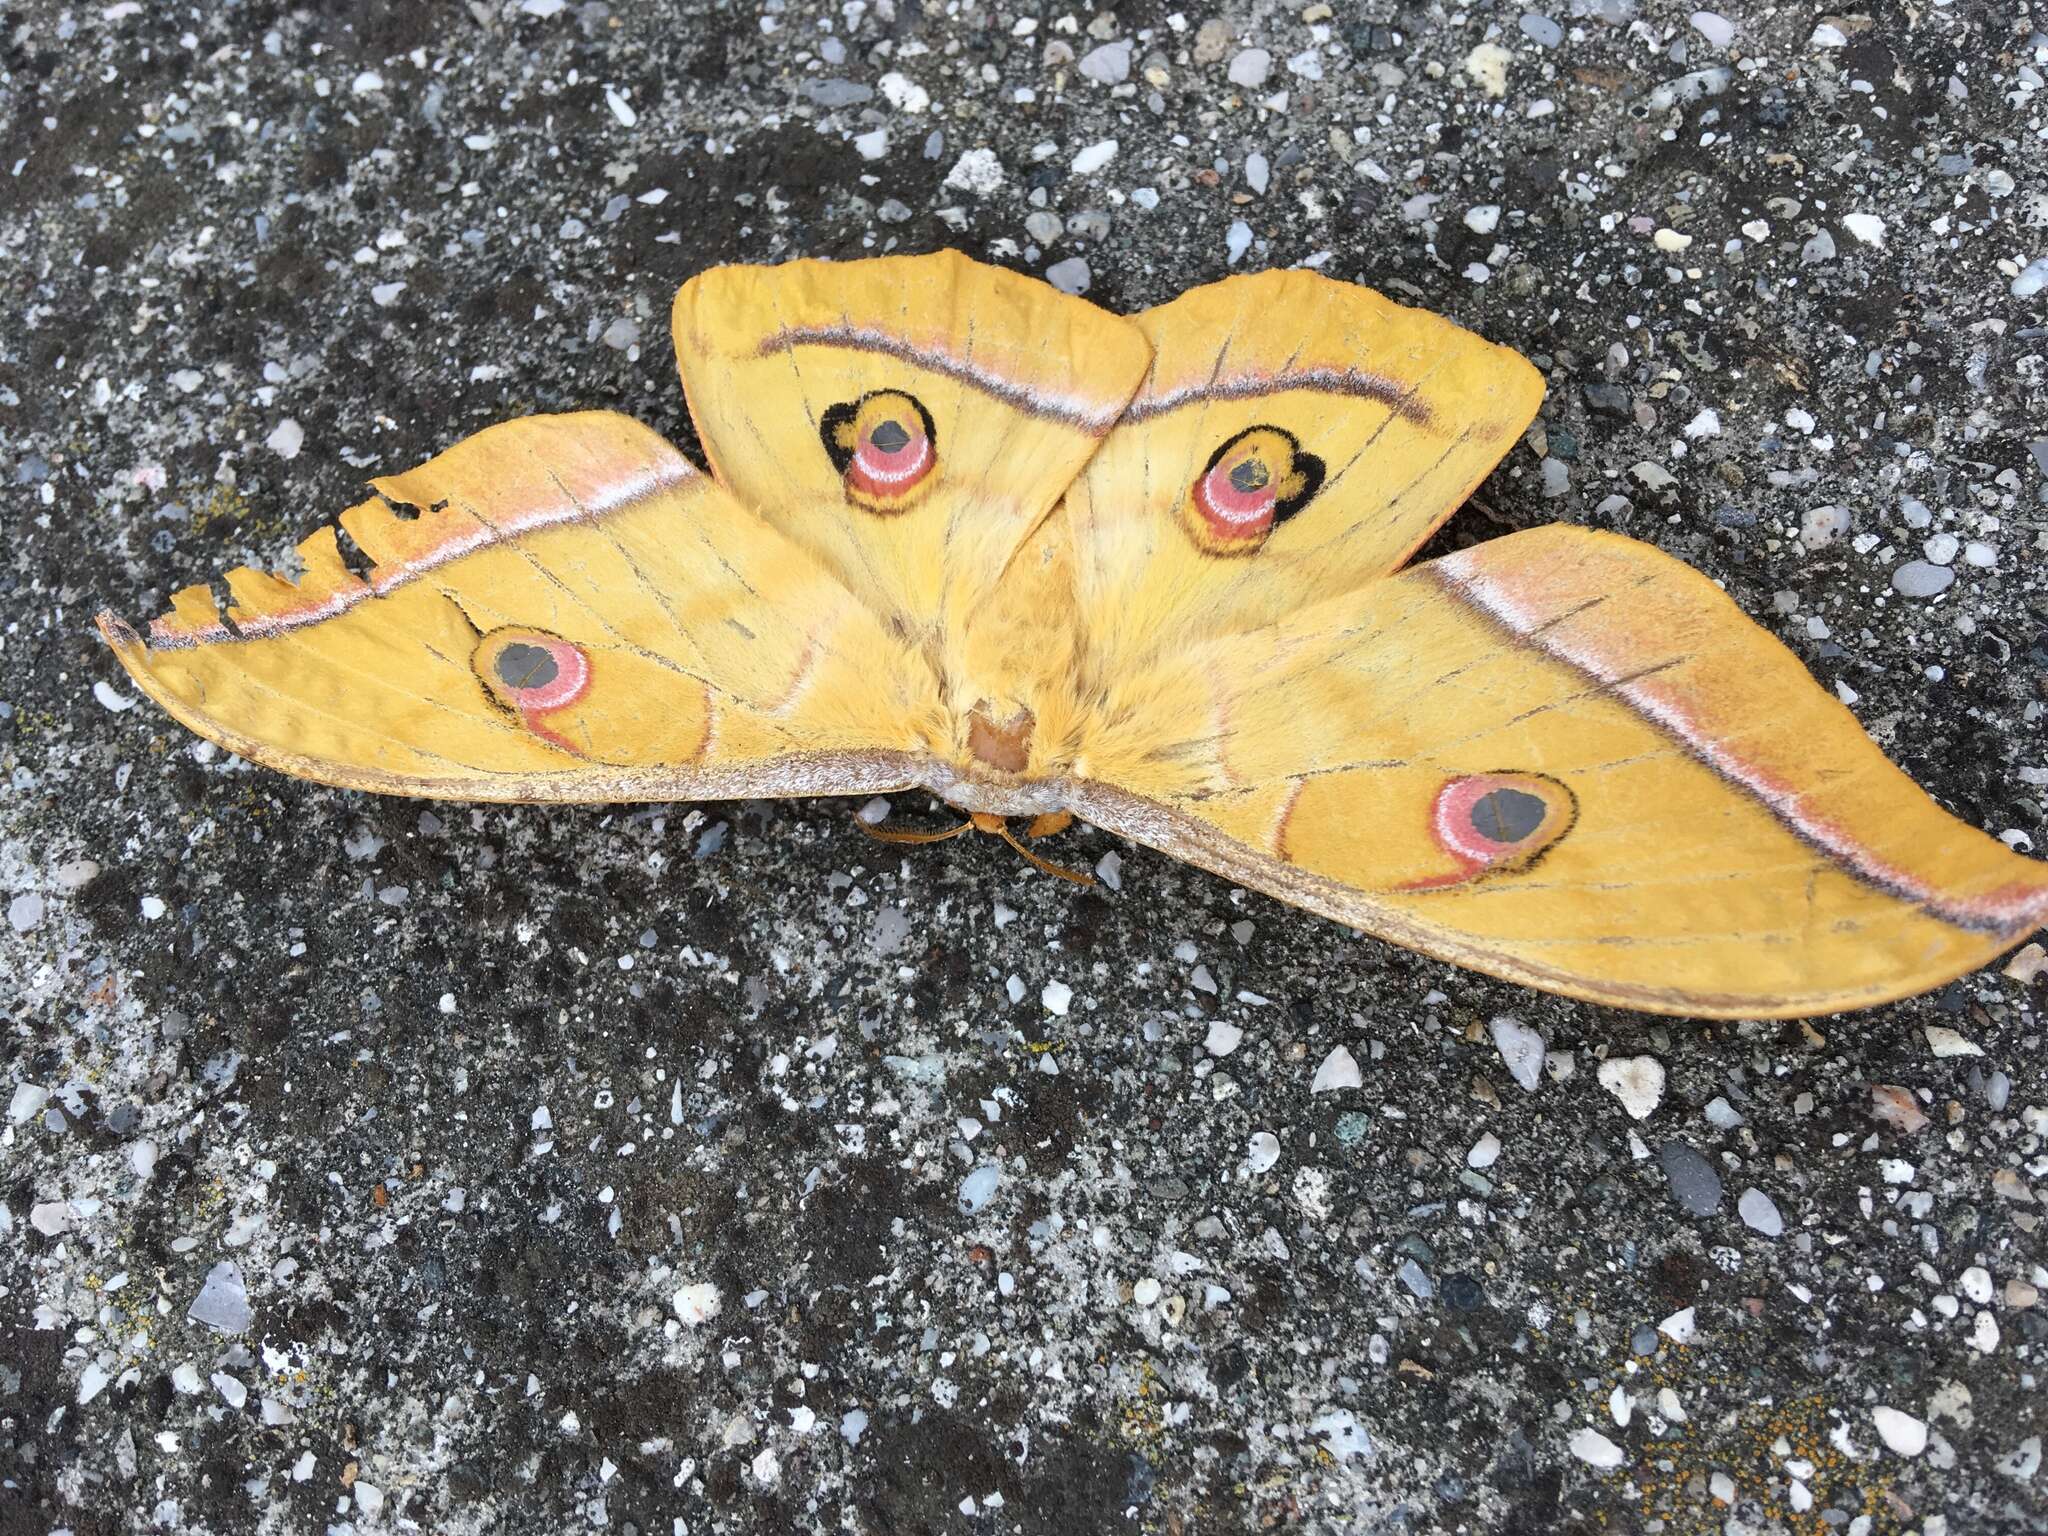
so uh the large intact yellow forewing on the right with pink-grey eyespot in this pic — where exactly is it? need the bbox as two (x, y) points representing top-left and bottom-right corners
(1075, 528), (2048, 1018)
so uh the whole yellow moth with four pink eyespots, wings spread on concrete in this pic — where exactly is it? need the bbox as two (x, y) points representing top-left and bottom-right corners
(98, 254), (2048, 1018)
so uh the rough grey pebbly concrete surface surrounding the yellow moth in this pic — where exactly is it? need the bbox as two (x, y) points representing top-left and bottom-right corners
(0, 0), (2048, 1536)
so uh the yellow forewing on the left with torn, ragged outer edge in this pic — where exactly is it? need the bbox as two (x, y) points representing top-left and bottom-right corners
(100, 412), (934, 801)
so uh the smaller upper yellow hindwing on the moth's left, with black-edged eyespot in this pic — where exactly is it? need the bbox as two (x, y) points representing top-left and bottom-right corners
(674, 252), (1149, 639)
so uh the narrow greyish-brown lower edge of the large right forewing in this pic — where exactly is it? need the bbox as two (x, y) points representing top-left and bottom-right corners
(1065, 780), (2028, 1018)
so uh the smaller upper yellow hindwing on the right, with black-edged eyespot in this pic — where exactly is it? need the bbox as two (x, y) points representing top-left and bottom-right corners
(1063, 270), (1542, 668)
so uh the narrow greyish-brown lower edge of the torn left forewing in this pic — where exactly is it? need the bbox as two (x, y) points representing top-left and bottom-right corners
(94, 612), (930, 805)
